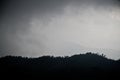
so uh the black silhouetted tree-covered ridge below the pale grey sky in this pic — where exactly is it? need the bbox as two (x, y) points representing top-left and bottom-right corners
(0, 53), (120, 80)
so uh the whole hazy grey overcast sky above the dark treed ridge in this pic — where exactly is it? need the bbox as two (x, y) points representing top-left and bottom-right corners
(0, 0), (120, 59)
